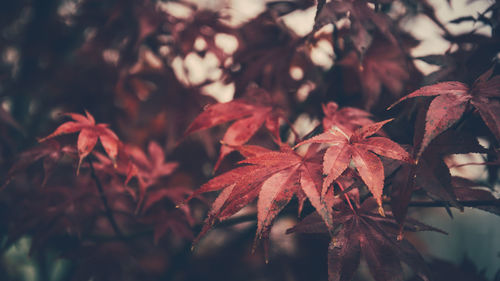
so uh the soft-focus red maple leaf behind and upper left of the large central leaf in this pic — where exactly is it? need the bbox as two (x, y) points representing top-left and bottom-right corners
(184, 87), (282, 170)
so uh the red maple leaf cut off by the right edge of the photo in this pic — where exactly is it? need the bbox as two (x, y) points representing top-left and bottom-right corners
(389, 68), (500, 158)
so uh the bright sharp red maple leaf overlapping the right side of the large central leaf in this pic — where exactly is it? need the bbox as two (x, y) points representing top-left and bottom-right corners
(297, 119), (411, 212)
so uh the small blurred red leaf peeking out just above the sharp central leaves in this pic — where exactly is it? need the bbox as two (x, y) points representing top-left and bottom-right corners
(322, 102), (373, 132)
